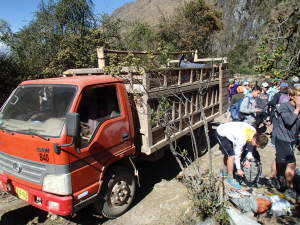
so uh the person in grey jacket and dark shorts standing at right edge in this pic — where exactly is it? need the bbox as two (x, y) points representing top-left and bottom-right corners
(272, 87), (300, 197)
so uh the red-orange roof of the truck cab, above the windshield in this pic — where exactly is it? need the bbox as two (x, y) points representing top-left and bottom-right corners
(21, 75), (122, 87)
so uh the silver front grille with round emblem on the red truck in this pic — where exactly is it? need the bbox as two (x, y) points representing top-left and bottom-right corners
(0, 152), (47, 184)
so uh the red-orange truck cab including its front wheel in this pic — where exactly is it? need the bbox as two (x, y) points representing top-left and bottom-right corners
(0, 75), (136, 218)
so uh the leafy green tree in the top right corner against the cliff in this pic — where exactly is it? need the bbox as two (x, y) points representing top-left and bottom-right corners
(256, 0), (300, 79)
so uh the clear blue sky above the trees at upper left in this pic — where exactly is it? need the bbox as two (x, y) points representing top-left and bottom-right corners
(0, 0), (134, 32)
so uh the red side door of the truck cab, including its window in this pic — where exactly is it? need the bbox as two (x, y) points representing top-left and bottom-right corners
(71, 84), (132, 199)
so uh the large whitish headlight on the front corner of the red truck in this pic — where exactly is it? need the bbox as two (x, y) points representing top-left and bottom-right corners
(43, 173), (72, 195)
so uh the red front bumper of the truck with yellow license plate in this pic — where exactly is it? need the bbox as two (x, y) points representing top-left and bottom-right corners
(0, 174), (73, 216)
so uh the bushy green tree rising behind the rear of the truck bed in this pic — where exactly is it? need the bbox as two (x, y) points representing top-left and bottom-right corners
(159, 0), (222, 55)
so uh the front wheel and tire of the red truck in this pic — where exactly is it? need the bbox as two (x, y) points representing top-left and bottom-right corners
(94, 167), (136, 219)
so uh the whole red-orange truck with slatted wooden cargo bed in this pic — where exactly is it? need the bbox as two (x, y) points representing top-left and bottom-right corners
(0, 57), (226, 218)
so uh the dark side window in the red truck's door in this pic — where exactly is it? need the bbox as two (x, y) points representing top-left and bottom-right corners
(78, 86), (120, 147)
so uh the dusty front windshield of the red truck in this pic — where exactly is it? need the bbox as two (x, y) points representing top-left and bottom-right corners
(0, 84), (76, 137)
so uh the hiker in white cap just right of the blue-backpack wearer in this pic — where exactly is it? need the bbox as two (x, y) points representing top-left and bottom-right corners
(255, 82), (269, 129)
